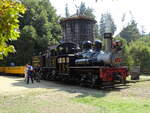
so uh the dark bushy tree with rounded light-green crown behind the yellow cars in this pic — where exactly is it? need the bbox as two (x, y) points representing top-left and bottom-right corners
(6, 25), (37, 65)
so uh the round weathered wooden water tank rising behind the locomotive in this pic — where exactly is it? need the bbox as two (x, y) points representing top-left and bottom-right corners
(60, 16), (96, 45)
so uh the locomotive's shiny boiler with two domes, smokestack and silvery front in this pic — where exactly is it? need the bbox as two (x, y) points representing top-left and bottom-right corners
(75, 33), (121, 66)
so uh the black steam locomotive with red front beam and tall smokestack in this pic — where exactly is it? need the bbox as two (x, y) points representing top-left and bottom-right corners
(32, 33), (128, 87)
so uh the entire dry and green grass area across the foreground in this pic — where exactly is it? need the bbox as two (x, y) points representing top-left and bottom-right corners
(0, 76), (150, 113)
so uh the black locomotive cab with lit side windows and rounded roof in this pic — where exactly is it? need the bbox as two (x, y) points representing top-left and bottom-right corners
(56, 43), (79, 75)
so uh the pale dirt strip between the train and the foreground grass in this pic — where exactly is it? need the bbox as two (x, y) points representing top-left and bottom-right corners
(0, 76), (150, 98)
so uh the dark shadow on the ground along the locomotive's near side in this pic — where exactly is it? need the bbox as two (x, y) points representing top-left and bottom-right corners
(0, 76), (130, 98)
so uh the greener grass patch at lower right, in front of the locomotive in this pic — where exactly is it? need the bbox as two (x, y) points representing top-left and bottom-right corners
(73, 76), (150, 113)
